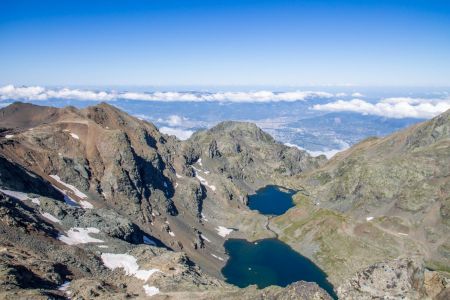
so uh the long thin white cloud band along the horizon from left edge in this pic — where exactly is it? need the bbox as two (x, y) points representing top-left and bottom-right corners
(0, 85), (334, 102)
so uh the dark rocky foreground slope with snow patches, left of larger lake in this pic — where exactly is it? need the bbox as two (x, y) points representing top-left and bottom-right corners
(0, 190), (330, 299)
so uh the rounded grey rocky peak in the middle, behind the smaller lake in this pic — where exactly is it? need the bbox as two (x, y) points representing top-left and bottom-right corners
(188, 121), (325, 192)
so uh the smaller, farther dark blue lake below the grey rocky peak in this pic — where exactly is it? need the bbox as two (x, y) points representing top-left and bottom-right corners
(248, 185), (295, 216)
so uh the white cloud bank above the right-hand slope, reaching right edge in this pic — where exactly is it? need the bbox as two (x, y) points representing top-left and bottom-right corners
(313, 97), (450, 119)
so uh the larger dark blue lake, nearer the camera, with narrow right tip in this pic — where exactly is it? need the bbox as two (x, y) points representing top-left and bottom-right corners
(222, 239), (336, 298)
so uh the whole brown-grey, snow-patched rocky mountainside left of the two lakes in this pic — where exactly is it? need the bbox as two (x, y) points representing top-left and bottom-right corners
(0, 103), (329, 299)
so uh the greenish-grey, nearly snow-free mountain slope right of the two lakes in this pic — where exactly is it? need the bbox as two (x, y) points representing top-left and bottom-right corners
(271, 111), (450, 284)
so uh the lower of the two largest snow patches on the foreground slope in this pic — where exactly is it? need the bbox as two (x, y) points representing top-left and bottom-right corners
(101, 253), (161, 281)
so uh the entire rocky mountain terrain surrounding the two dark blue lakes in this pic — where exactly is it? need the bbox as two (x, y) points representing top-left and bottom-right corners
(0, 103), (450, 299)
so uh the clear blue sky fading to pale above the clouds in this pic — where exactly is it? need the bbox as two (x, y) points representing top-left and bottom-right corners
(0, 0), (450, 87)
